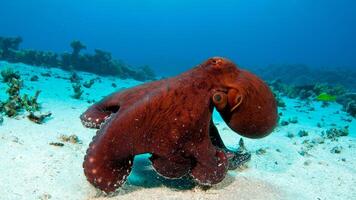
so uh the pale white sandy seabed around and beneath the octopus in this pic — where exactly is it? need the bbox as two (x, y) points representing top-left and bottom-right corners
(0, 62), (356, 200)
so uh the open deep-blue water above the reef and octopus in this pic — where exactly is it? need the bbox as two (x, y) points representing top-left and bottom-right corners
(0, 0), (356, 75)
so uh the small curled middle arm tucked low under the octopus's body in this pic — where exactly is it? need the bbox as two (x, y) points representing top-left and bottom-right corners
(150, 155), (192, 179)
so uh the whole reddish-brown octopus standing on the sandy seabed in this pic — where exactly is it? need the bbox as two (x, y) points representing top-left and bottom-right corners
(80, 57), (278, 193)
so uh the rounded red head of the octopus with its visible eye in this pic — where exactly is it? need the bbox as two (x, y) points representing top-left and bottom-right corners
(202, 57), (278, 138)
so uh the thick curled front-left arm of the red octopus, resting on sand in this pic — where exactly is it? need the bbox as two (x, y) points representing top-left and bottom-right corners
(83, 113), (134, 193)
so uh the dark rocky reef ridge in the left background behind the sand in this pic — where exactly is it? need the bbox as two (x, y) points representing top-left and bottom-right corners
(0, 37), (156, 81)
